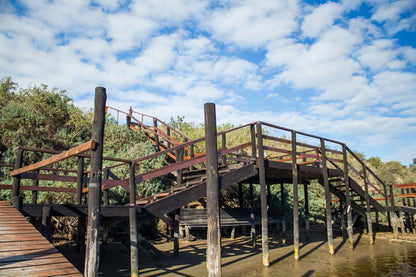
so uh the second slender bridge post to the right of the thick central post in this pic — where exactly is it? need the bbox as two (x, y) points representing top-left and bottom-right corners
(292, 131), (299, 260)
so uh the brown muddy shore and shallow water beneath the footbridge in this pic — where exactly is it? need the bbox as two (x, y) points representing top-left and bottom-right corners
(58, 232), (416, 276)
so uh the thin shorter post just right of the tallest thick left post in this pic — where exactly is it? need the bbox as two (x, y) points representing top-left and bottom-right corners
(129, 163), (139, 277)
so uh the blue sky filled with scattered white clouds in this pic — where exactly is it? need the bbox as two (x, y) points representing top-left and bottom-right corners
(0, 0), (416, 164)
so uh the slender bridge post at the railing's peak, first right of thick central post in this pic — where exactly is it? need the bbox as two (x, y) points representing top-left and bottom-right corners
(256, 122), (269, 266)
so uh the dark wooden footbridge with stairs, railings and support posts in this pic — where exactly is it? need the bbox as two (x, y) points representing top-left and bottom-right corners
(0, 85), (416, 276)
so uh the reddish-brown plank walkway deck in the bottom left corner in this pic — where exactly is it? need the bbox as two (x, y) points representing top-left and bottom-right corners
(0, 201), (83, 276)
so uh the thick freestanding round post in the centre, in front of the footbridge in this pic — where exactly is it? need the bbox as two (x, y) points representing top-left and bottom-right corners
(204, 103), (221, 277)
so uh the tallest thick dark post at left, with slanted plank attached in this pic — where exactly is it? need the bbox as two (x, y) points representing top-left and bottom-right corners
(84, 87), (107, 277)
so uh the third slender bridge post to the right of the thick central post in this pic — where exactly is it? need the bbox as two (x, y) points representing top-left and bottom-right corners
(321, 139), (334, 255)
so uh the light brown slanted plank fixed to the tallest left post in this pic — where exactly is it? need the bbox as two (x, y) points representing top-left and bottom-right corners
(10, 140), (96, 176)
